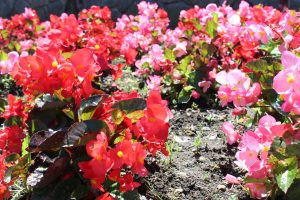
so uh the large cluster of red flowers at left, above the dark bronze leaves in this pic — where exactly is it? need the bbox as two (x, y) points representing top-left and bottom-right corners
(12, 48), (101, 105)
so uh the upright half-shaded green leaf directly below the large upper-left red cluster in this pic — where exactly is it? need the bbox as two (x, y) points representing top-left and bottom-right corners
(78, 95), (102, 121)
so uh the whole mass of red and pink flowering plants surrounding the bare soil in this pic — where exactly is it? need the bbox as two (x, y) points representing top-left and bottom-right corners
(0, 1), (300, 199)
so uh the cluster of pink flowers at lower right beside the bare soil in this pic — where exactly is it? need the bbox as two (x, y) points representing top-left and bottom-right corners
(223, 115), (299, 199)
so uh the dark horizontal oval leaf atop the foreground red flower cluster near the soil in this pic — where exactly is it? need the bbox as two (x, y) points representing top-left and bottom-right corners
(112, 98), (147, 113)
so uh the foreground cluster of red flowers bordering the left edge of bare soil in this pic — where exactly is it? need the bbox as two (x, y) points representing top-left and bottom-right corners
(79, 91), (172, 195)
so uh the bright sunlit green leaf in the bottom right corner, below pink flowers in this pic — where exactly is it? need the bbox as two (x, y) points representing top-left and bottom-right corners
(275, 157), (298, 193)
